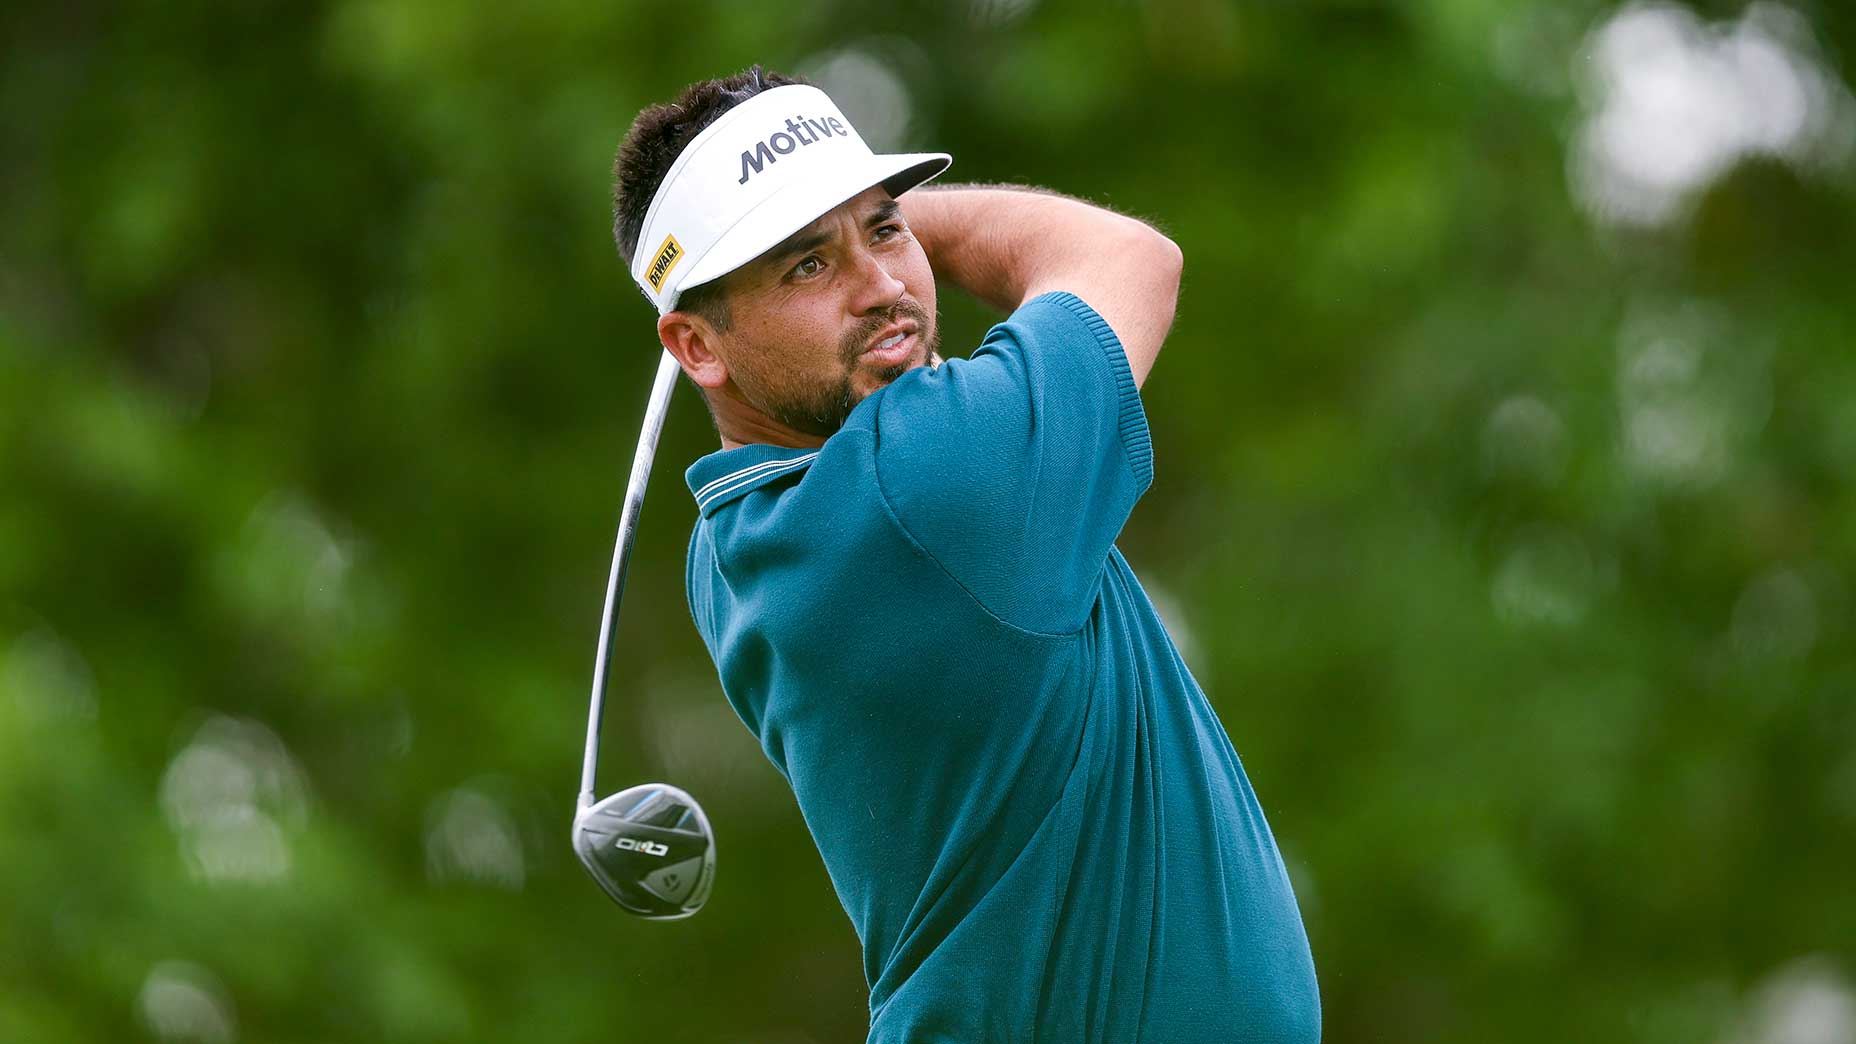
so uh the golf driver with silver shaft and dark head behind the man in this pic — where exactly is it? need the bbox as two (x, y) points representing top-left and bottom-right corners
(574, 351), (715, 921)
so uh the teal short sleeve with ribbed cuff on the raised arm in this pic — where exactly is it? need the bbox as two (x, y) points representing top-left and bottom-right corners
(874, 286), (1153, 633)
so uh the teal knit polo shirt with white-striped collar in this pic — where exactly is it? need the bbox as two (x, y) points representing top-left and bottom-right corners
(687, 294), (1321, 1044)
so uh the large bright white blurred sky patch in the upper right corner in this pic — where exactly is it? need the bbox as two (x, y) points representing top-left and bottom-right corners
(1572, 4), (1856, 225)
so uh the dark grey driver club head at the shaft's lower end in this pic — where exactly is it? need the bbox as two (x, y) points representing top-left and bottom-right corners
(574, 784), (715, 921)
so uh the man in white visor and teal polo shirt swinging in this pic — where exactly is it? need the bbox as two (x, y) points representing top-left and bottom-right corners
(614, 67), (1320, 1044)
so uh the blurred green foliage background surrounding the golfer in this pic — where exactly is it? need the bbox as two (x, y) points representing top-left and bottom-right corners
(0, 0), (1856, 1044)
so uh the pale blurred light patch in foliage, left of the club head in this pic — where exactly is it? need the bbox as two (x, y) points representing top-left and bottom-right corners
(161, 717), (308, 882)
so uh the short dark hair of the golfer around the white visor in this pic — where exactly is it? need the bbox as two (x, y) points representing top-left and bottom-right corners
(612, 65), (806, 331)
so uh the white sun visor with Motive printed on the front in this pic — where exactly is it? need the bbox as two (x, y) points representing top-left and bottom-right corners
(631, 84), (954, 316)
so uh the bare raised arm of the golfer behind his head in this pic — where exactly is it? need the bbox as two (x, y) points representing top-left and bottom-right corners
(900, 186), (1182, 386)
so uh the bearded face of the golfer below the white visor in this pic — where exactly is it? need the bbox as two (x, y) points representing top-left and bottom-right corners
(697, 188), (939, 438)
